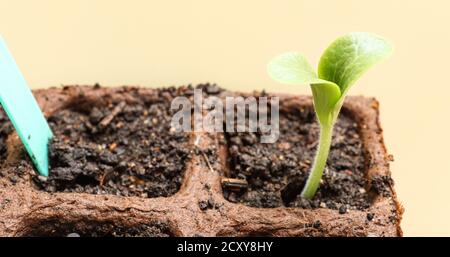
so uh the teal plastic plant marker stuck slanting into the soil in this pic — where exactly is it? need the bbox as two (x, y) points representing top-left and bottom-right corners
(0, 36), (53, 176)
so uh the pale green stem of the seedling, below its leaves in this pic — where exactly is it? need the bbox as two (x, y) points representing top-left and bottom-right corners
(301, 125), (333, 199)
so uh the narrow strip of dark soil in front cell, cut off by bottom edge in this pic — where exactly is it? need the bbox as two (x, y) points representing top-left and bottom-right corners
(21, 219), (172, 237)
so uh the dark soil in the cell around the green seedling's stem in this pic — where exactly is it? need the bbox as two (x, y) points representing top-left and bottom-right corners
(224, 106), (376, 210)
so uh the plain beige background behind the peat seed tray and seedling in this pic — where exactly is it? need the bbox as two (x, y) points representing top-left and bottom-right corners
(0, 0), (450, 236)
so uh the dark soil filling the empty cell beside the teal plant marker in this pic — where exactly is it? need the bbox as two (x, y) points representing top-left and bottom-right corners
(34, 88), (190, 197)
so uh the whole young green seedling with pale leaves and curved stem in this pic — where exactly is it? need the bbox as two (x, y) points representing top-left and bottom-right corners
(267, 32), (393, 199)
